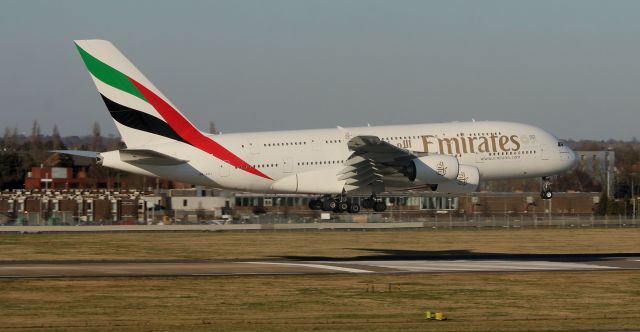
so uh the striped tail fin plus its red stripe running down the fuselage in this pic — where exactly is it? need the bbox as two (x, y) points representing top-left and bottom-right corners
(75, 39), (271, 179)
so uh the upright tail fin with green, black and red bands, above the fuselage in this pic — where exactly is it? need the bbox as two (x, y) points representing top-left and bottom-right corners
(75, 39), (199, 148)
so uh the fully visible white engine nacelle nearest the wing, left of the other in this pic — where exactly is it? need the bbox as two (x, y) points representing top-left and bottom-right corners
(405, 154), (460, 184)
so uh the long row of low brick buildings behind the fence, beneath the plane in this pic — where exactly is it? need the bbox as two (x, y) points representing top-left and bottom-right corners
(0, 189), (599, 225)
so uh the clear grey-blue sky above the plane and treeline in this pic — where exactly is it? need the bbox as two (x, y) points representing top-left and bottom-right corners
(0, 0), (640, 140)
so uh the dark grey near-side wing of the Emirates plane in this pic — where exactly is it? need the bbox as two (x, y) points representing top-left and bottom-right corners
(338, 136), (418, 191)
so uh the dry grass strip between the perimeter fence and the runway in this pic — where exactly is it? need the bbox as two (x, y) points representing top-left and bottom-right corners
(0, 228), (640, 261)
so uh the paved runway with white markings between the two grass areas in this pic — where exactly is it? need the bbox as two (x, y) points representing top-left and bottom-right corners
(0, 254), (640, 278)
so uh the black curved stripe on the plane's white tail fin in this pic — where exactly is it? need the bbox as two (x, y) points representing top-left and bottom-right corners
(100, 94), (187, 143)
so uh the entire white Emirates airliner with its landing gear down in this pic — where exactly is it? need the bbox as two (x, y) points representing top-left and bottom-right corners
(57, 40), (576, 213)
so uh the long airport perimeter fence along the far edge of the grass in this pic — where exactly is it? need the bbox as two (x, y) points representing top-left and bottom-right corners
(0, 210), (640, 230)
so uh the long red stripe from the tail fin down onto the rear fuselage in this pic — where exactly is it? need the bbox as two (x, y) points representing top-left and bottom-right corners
(129, 77), (273, 180)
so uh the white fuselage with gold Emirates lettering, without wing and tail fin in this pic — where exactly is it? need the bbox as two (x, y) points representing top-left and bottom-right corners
(102, 121), (576, 194)
